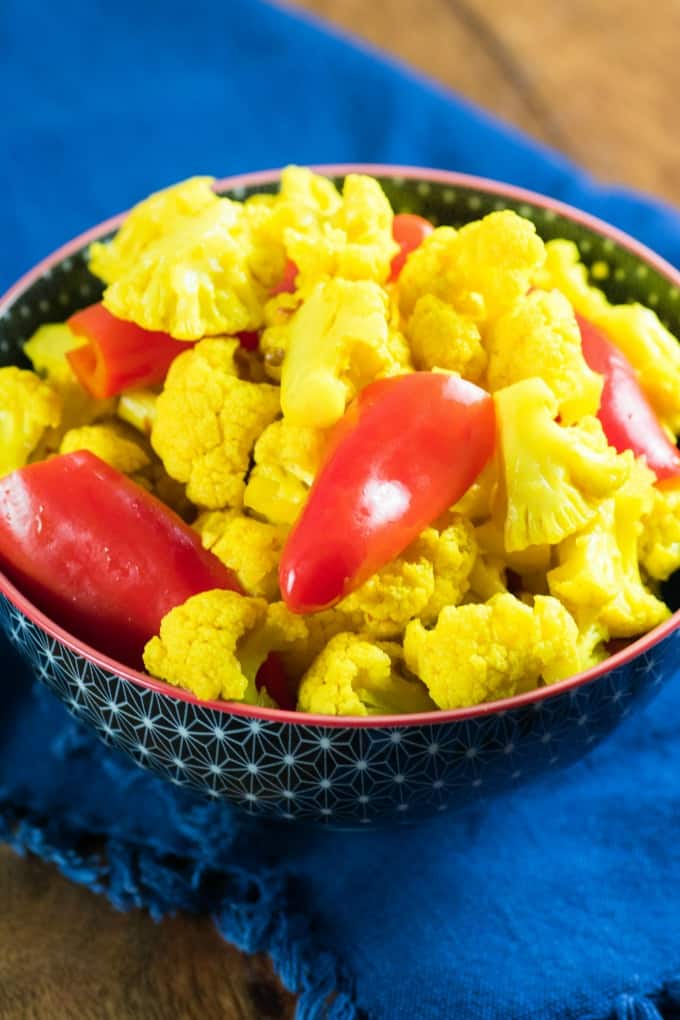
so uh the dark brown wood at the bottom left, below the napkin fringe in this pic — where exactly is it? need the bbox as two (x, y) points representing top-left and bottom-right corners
(0, 848), (295, 1020)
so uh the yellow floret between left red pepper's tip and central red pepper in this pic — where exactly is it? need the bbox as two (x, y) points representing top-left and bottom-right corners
(194, 510), (287, 602)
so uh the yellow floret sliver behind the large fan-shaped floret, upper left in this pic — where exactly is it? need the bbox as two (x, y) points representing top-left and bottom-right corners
(90, 177), (217, 284)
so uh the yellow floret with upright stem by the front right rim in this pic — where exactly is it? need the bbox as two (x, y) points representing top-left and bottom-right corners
(547, 452), (670, 638)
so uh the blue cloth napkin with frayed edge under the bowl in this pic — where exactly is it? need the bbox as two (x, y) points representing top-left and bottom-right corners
(0, 0), (680, 1020)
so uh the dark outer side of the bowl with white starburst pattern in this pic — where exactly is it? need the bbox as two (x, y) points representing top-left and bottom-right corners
(0, 598), (680, 825)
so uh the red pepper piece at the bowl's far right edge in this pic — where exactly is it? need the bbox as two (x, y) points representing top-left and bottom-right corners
(576, 315), (680, 481)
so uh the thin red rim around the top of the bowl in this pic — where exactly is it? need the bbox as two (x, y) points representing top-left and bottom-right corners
(0, 163), (680, 728)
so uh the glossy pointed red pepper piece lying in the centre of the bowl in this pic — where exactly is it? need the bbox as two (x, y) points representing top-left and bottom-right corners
(279, 372), (495, 613)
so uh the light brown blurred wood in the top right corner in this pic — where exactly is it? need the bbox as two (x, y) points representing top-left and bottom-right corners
(298, 0), (680, 204)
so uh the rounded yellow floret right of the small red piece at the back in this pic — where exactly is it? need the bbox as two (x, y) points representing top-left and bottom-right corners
(398, 209), (545, 323)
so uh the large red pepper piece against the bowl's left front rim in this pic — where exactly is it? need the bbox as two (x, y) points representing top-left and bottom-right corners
(0, 451), (242, 667)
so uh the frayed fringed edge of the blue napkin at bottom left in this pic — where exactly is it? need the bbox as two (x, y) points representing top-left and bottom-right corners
(0, 795), (365, 1020)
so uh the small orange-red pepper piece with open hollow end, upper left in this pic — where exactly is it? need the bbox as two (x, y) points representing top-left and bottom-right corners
(66, 304), (194, 400)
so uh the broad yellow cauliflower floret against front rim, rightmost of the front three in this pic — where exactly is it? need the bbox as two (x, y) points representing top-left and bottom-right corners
(404, 593), (578, 709)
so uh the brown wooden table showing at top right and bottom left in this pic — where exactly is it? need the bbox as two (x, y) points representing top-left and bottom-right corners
(0, 0), (680, 1020)
